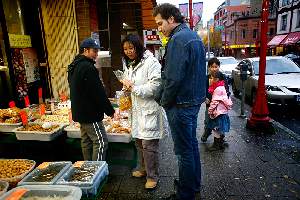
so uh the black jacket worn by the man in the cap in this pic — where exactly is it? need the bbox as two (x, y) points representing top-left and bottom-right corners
(68, 55), (115, 123)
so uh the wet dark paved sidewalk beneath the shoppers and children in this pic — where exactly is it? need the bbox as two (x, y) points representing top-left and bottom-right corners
(99, 98), (300, 200)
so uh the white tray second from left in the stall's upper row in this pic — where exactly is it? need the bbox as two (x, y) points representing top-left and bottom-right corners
(13, 125), (63, 141)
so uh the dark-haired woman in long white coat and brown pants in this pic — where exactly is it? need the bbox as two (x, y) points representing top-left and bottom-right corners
(121, 34), (169, 189)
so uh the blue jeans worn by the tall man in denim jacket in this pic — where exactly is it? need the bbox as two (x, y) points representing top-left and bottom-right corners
(166, 105), (201, 200)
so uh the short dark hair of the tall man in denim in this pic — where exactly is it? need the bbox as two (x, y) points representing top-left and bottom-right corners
(153, 3), (184, 23)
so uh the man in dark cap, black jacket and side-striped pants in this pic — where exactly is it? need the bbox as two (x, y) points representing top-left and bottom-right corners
(68, 38), (115, 160)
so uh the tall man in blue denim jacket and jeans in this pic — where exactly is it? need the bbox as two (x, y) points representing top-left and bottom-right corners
(153, 3), (206, 200)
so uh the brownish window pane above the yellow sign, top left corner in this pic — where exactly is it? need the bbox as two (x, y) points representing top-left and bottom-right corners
(2, 0), (25, 35)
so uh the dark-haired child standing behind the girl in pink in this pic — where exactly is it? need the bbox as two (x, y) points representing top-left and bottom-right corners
(201, 57), (230, 145)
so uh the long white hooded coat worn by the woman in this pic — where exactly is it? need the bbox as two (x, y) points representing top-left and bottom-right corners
(123, 50), (169, 140)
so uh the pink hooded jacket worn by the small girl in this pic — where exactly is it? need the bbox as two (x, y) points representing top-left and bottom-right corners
(208, 86), (232, 119)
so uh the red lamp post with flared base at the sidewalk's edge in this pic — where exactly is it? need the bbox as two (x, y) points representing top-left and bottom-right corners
(247, 0), (273, 132)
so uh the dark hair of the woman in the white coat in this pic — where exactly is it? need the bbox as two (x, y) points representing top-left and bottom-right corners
(121, 34), (145, 64)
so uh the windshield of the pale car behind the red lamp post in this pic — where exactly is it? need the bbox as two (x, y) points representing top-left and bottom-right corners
(253, 58), (300, 75)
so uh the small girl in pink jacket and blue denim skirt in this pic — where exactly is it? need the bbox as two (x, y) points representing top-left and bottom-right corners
(207, 80), (232, 151)
